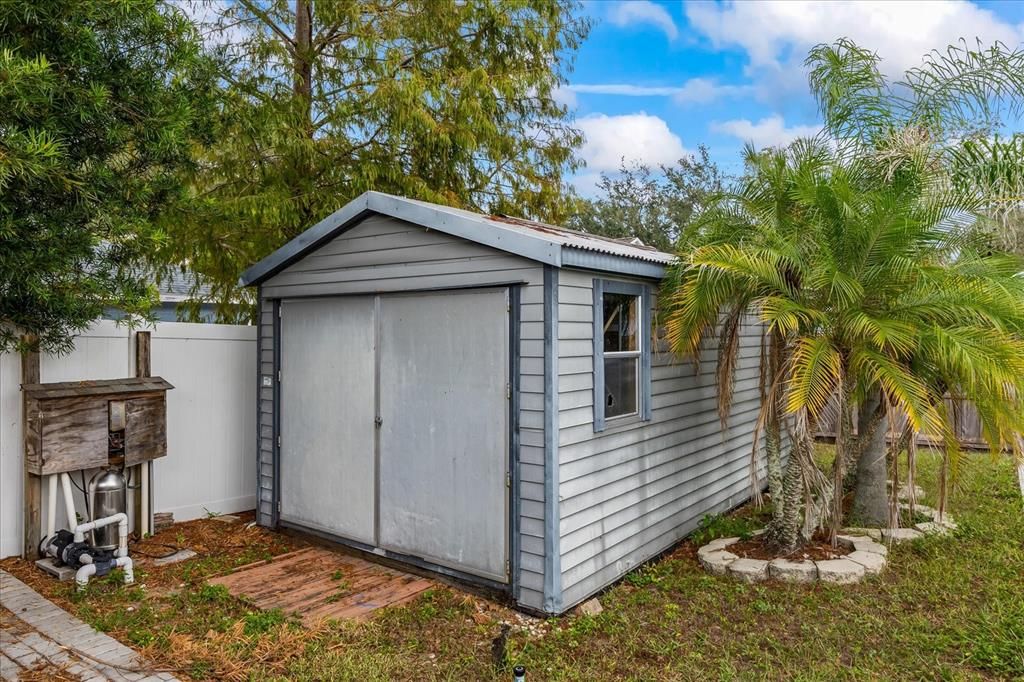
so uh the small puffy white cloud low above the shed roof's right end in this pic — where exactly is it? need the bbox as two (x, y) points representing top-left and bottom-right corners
(575, 112), (686, 172)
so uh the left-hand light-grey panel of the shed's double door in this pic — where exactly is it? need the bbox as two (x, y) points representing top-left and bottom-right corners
(280, 297), (376, 544)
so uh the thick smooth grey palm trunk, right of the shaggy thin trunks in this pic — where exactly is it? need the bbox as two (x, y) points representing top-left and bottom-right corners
(853, 390), (889, 526)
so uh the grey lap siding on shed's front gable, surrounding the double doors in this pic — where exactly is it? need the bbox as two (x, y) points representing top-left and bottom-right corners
(252, 215), (544, 609)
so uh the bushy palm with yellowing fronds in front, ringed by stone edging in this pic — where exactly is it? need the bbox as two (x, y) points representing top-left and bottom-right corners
(665, 137), (1024, 549)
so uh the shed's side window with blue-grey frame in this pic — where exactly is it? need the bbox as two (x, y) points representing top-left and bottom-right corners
(594, 280), (650, 431)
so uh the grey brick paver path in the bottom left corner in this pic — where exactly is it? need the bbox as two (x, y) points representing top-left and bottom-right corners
(0, 570), (177, 682)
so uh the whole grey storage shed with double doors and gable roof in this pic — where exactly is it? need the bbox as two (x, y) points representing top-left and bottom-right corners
(242, 193), (760, 613)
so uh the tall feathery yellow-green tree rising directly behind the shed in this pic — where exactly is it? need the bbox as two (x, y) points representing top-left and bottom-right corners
(161, 0), (589, 316)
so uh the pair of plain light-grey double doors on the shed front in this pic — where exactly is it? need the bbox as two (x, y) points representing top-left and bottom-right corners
(280, 289), (509, 582)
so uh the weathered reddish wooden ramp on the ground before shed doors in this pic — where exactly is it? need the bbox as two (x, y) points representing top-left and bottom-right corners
(208, 547), (434, 626)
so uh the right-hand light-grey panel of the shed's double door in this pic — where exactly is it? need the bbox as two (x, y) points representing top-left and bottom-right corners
(379, 289), (509, 582)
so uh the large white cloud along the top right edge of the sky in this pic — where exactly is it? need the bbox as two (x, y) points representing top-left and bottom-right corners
(685, 0), (1024, 77)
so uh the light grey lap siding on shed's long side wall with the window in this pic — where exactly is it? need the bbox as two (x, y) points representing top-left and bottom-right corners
(558, 269), (760, 608)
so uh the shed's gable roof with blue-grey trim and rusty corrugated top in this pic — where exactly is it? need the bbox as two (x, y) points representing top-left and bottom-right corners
(235, 191), (674, 286)
